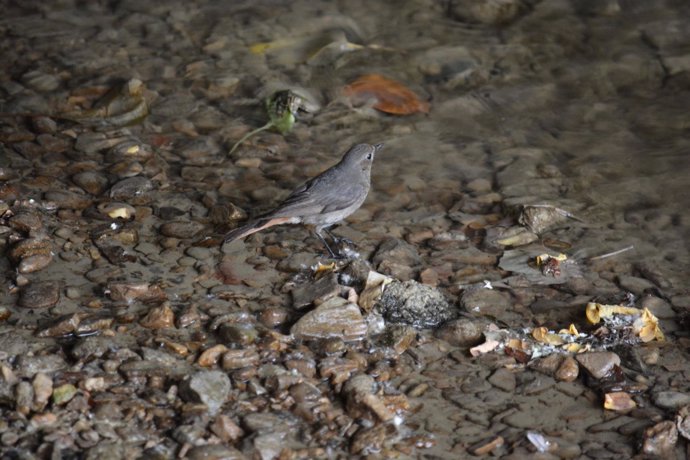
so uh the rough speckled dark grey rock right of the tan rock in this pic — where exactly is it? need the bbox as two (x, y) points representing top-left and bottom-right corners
(377, 281), (456, 328)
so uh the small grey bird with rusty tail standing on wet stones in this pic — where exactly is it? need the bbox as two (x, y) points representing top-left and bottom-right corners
(225, 144), (383, 258)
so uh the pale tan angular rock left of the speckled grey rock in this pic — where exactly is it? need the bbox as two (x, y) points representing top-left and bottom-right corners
(290, 297), (367, 342)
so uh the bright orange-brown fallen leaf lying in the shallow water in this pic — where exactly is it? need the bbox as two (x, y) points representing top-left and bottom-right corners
(343, 74), (429, 115)
